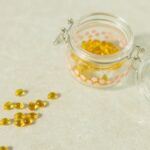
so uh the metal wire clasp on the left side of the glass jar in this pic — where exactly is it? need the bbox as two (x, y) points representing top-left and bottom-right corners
(53, 18), (74, 45)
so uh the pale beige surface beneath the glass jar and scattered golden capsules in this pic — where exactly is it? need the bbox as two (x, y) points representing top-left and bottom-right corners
(0, 0), (150, 150)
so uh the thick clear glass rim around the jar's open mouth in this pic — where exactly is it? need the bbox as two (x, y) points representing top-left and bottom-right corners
(68, 12), (134, 64)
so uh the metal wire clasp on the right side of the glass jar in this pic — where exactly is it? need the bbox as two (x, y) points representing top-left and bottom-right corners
(129, 46), (145, 70)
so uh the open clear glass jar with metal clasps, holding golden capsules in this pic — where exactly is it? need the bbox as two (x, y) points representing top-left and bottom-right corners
(55, 13), (142, 87)
